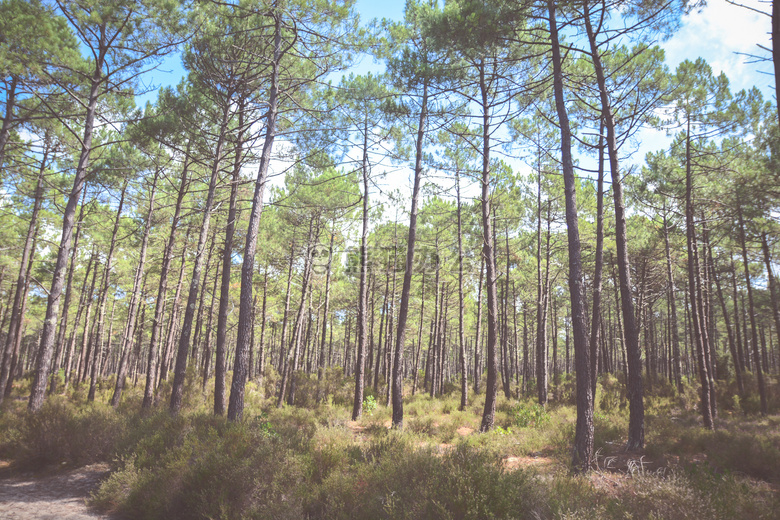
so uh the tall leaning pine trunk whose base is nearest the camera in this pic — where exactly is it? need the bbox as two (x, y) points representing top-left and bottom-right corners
(547, 0), (593, 471)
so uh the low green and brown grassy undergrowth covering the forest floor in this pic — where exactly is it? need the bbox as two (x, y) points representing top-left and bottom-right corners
(0, 373), (780, 520)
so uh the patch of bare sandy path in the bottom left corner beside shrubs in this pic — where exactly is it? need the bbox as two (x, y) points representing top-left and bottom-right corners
(0, 461), (110, 520)
